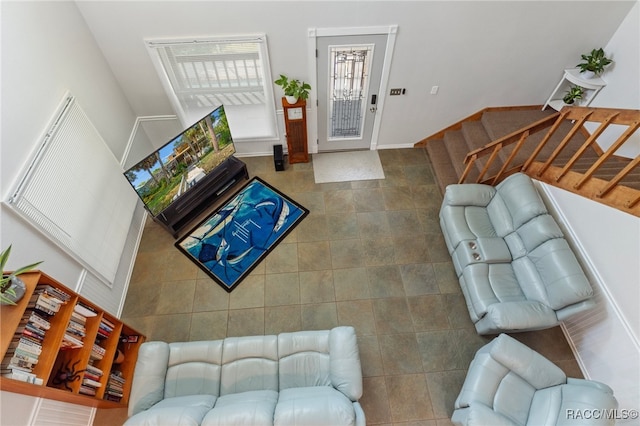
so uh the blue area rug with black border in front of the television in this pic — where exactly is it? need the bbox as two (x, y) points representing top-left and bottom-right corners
(175, 177), (309, 292)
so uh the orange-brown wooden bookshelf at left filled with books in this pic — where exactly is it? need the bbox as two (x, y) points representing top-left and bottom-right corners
(0, 271), (145, 408)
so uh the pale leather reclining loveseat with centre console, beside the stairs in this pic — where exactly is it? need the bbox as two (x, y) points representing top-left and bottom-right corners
(440, 173), (594, 334)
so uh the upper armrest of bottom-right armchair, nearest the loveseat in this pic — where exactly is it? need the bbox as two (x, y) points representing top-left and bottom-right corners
(481, 334), (567, 389)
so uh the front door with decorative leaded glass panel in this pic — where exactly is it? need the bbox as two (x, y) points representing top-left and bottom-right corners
(316, 34), (387, 152)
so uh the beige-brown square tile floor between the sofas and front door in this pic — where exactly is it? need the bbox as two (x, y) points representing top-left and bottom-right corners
(94, 149), (581, 425)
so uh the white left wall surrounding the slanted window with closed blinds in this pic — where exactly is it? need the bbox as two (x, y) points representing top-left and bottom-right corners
(0, 1), (148, 424)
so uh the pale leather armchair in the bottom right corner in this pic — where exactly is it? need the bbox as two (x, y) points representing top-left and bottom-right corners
(451, 334), (618, 426)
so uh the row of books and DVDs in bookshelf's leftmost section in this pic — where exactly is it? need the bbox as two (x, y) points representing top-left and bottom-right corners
(0, 284), (71, 385)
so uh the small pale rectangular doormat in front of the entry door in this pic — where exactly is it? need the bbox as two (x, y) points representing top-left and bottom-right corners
(313, 151), (384, 183)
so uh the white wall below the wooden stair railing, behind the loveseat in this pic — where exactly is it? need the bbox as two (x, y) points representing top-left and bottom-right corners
(541, 184), (640, 424)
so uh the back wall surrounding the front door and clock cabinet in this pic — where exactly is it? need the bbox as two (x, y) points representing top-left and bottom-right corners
(79, 1), (633, 152)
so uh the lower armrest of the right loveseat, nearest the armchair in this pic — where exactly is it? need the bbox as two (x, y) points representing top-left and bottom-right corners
(476, 300), (558, 334)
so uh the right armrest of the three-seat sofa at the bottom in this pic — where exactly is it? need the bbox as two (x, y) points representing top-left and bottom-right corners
(329, 326), (362, 401)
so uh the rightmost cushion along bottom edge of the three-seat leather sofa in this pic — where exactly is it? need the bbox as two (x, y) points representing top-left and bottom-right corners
(274, 386), (356, 426)
